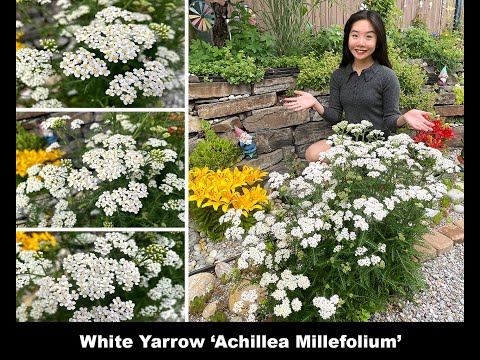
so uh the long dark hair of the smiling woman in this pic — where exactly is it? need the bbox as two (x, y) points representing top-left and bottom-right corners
(340, 10), (392, 69)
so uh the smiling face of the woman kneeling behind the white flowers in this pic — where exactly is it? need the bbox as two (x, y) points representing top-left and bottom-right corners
(348, 20), (377, 63)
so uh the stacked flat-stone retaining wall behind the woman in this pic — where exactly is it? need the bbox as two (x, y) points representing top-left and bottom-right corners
(189, 63), (463, 171)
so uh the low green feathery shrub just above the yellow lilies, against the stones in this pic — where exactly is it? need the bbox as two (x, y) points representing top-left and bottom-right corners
(189, 120), (242, 170)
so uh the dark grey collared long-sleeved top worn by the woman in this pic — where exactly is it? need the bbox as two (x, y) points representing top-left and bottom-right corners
(322, 61), (401, 137)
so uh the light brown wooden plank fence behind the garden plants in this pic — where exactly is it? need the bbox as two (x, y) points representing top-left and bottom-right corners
(238, 0), (464, 33)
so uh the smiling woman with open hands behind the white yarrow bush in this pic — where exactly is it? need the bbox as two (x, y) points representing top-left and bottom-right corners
(284, 10), (433, 161)
